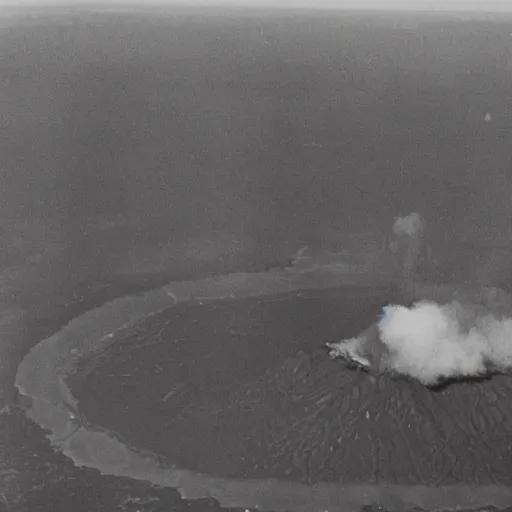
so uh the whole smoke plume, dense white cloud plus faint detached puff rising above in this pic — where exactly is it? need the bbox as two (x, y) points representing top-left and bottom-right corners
(327, 213), (512, 386)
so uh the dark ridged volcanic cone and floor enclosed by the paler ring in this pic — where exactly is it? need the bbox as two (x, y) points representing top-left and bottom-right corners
(68, 286), (512, 486)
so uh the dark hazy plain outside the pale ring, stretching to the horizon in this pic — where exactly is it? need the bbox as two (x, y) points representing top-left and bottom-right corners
(0, 5), (512, 512)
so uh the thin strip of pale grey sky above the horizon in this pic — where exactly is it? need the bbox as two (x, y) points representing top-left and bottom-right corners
(0, 0), (512, 12)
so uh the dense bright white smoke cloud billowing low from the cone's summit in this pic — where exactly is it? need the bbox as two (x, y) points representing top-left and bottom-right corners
(328, 290), (512, 386)
